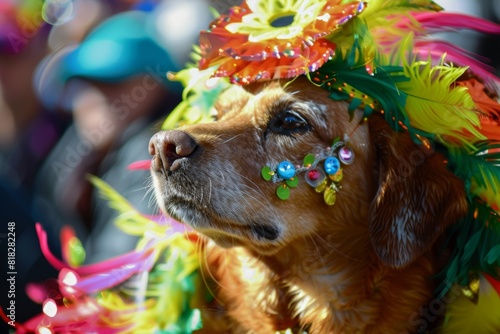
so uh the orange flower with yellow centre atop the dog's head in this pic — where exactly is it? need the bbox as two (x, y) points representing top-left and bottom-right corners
(199, 0), (366, 84)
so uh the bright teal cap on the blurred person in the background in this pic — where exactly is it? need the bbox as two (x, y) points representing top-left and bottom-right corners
(59, 11), (177, 87)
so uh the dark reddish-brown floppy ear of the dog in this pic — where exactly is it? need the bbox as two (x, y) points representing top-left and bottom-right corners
(369, 116), (467, 268)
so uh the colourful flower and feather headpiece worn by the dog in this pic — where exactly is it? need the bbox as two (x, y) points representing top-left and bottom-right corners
(165, 0), (500, 308)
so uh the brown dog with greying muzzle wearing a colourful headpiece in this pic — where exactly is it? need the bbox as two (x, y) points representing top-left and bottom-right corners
(150, 78), (467, 334)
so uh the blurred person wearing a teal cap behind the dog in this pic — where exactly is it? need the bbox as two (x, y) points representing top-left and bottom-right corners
(31, 0), (211, 263)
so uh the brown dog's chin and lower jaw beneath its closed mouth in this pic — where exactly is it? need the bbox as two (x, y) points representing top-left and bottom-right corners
(164, 199), (282, 254)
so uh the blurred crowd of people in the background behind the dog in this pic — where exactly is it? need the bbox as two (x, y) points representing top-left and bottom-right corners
(0, 0), (500, 321)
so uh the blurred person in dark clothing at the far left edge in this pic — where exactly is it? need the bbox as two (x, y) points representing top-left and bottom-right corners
(0, 0), (71, 333)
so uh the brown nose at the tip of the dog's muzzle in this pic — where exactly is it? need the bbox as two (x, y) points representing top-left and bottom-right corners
(149, 130), (197, 172)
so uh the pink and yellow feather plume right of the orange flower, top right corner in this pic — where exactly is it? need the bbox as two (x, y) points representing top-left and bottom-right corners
(352, 0), (500, 83)
